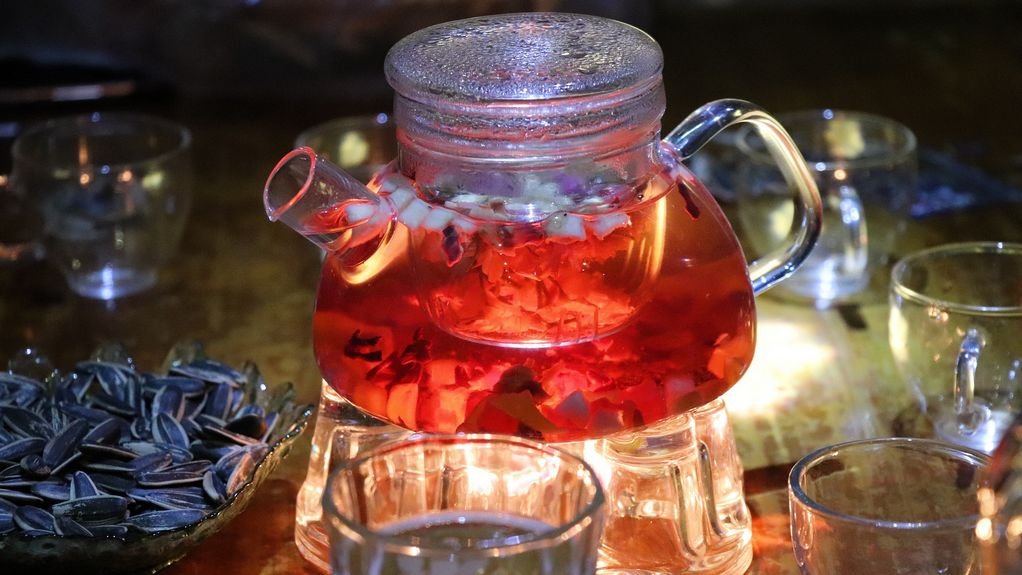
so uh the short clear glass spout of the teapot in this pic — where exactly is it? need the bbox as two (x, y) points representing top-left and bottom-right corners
(263, 147), (393, 252)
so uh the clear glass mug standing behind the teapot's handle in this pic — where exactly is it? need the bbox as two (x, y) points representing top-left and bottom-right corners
(735, 109), (917, 305)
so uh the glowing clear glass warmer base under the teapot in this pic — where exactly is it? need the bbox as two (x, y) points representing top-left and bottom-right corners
(294, 382), (752, 575)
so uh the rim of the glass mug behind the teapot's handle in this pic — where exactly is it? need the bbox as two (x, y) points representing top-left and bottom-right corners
(735, 108), (918, 173)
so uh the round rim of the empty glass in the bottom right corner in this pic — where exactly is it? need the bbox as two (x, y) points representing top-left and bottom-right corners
(788, 437), (990, 531)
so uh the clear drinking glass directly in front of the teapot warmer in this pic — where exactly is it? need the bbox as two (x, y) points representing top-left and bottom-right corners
(323, 435), (604, 575)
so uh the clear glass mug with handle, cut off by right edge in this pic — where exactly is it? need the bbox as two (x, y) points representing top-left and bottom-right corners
(889, 242), (1022, 452)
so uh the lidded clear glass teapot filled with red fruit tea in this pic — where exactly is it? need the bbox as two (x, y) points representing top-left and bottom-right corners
(264, 13), (821, 441)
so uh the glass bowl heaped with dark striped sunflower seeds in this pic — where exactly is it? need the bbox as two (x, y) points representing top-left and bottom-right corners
(0, 342), (313, 575)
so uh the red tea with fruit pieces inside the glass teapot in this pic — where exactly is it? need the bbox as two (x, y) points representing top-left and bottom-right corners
(314, 169), (755, 441)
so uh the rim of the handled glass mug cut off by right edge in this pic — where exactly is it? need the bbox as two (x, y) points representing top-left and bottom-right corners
(890, 242), (1022, 317)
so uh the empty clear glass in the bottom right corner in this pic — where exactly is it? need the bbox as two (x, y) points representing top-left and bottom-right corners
(788, 437), (987, 575)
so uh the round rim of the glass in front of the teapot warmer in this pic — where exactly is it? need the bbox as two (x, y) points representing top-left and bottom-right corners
(323, 433), (606, 558)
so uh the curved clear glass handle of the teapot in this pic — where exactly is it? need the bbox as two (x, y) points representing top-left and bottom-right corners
(664, 99), (823, 294)
